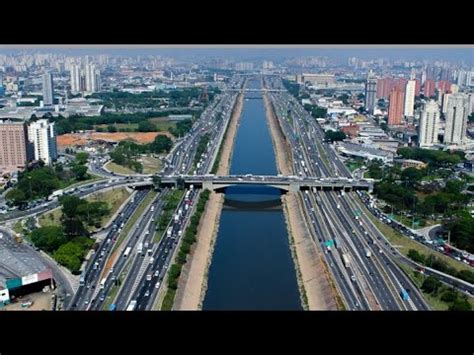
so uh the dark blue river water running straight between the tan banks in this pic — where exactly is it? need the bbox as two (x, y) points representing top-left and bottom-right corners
(203, 80), (302, 310)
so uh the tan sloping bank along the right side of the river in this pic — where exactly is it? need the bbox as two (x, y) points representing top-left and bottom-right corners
(263, 95), (337, 310)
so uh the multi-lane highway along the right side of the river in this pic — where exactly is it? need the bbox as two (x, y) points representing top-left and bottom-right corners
(265, 78), (428, 310)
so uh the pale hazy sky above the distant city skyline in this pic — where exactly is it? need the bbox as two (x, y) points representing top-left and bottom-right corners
(0, 45), (474, 64)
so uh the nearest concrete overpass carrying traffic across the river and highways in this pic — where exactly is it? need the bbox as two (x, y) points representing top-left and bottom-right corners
(156, 174), (373, 192)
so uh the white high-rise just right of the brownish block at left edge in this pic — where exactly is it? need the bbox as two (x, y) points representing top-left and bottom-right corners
(28, 119), (58, 165)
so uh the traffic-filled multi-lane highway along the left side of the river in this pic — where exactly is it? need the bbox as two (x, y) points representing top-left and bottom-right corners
(71, 78), (244, 310)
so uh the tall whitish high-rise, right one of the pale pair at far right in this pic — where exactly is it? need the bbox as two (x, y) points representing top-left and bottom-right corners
(444, 93), (469, 144)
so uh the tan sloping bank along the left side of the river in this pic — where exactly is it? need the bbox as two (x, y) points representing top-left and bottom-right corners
(173, 94), (244, 310)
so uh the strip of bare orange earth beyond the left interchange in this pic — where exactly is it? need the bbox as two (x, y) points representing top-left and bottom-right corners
(57, 132), (173, 148)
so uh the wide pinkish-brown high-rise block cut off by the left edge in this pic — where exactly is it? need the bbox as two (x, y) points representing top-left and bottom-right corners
(0, 121), (31, 173)
